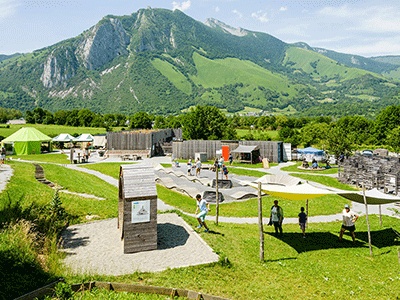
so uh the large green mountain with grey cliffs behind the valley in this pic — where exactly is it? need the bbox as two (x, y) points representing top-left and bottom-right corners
(0, 8), (400, 115)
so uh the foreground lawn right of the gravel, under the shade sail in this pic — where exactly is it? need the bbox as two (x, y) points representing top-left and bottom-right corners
(66, 215), (400, 300)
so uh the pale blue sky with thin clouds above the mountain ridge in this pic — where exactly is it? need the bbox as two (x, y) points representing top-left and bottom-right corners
(0, 0), (400, 57)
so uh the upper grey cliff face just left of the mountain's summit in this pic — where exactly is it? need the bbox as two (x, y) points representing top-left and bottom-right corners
(76, 18), (130, 70)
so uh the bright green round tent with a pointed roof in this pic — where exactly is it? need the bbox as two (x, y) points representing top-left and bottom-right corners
(1, 127), (51, 155)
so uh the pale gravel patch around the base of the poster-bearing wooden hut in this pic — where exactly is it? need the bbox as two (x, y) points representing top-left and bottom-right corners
(61, 213), (219, 276)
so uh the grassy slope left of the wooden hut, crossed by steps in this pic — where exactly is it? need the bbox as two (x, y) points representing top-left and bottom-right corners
(0, 161), (118, 223)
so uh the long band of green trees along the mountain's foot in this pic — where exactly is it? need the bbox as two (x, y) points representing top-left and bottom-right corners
(0, 105), (400, 155)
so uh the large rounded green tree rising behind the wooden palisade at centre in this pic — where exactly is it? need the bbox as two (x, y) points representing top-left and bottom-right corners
(182, 105), (232, 140)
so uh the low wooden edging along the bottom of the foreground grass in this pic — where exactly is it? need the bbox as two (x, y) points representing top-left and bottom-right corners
(15, 278), (229, 300)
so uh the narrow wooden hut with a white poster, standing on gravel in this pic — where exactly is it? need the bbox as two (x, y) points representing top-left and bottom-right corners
(118, 165), (157, 253)
